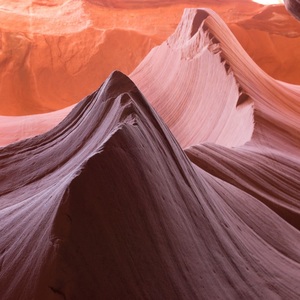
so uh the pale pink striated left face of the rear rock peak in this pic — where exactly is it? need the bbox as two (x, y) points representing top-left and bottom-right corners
(130, 10), (253, 148)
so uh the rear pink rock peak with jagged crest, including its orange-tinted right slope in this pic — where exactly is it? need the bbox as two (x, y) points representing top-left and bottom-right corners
(131, 10), (300, 148)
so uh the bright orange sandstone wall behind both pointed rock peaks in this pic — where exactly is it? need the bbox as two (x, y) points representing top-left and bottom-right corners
(0, 0), (300, 115)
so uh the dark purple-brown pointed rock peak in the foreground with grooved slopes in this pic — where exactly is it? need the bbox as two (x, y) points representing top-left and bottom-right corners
(0, 72), (300, 299)
